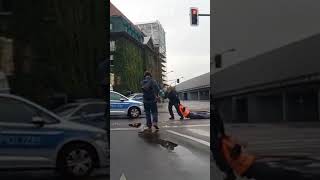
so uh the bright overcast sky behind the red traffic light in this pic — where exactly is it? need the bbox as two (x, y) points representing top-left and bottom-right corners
(111, 0), (210, 81)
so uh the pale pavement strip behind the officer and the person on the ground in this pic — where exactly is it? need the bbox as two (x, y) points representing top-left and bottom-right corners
(158, 101), (210, 113)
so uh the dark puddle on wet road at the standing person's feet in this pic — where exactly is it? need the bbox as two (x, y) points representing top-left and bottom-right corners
(139, 130), (178, 151)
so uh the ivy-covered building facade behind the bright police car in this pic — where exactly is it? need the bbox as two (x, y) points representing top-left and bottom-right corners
(110, 3), (162, 93)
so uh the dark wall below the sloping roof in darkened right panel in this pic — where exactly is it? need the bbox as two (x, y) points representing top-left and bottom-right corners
(216, 85), (320, 123)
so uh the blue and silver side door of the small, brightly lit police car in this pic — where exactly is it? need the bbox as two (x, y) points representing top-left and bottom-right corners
(110, 92), (130, 115)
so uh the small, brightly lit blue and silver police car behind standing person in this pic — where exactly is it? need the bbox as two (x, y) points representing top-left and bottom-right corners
(110, 91), (144, 118)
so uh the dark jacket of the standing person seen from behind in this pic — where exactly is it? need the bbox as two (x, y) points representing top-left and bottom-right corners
(141, 76), (160, 103)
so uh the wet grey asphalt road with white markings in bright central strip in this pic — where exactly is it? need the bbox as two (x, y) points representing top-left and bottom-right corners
(110, 113), (210, 180)
